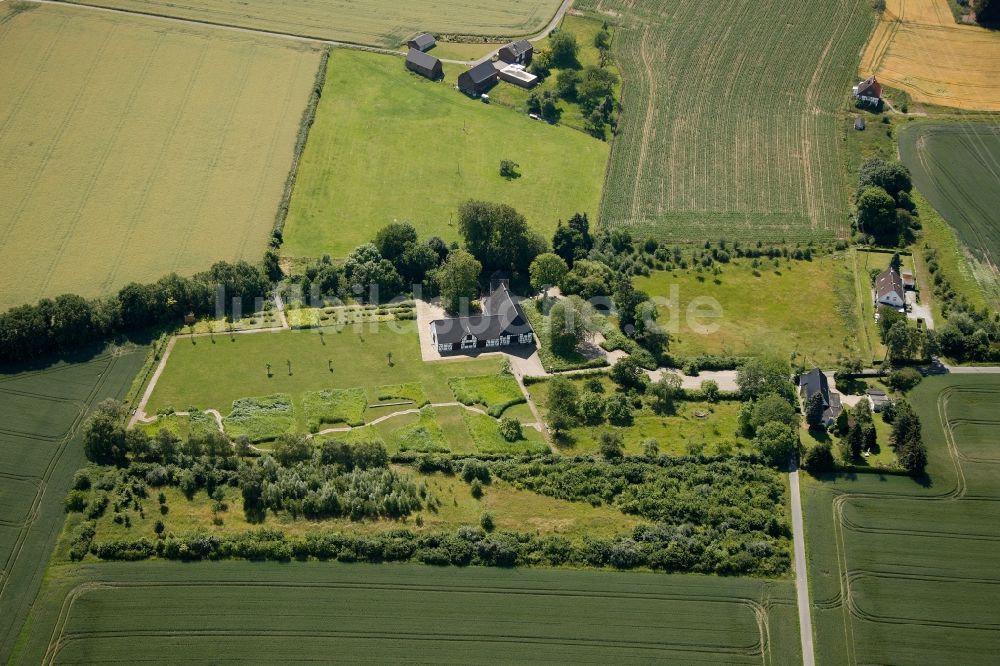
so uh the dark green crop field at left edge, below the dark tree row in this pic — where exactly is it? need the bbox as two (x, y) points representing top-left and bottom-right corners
(0, 349), (144, 662)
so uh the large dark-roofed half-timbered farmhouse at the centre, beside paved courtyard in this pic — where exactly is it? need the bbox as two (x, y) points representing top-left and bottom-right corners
(430, 282), (535, 353)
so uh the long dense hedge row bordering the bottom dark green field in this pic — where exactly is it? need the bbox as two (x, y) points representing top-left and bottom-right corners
(91, 525), (790, 576)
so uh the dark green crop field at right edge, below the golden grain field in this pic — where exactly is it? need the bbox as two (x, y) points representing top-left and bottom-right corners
(899, 122), (1000, 292)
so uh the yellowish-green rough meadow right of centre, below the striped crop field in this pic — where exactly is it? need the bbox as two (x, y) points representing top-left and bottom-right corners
(635, 253), (860, 366)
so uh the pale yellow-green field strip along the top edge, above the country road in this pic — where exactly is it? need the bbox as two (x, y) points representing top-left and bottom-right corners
(64, 0), (561, 48)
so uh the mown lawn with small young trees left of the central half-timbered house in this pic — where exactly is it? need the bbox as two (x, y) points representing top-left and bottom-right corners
(146, 321), (500, 414)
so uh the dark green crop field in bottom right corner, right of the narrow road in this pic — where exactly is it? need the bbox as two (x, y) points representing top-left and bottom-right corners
(805, 375), (1000, 664)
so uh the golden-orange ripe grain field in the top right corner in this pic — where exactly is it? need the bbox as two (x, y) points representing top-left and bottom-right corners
(860, 0), (1000, 111)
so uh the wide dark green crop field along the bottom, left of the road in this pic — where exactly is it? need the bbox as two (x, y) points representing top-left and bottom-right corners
(14, 562), (801, 666)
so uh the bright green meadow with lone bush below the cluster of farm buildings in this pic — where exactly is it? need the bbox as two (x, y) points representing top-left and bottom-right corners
(282, 50), (608, 257)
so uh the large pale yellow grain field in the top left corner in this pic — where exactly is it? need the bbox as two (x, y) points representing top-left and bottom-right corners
(0, 2), (320, 309)
